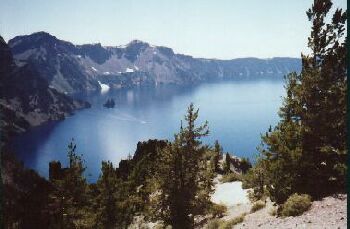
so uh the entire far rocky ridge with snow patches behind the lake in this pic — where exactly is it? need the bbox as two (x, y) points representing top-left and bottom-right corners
(9, 32), (301, 94)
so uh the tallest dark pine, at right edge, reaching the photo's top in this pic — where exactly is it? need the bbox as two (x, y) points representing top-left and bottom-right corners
(299, 0), (347, 196)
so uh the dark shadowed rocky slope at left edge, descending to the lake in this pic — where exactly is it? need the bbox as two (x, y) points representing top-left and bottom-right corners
(0, 37), (88, 137)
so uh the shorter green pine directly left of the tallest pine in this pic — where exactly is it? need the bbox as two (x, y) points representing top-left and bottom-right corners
(256, 73), (302, 204)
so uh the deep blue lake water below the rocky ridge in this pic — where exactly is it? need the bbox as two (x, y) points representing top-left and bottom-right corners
(15, 81), (284, 181)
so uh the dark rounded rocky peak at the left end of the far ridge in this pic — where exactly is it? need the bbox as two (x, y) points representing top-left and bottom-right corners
(9, 32), (99, 93)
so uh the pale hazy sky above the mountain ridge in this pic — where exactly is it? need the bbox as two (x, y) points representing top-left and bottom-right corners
(0, 0), (346, 59)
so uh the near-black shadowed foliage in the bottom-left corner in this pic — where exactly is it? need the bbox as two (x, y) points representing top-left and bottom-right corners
(1, 150), (52, 229)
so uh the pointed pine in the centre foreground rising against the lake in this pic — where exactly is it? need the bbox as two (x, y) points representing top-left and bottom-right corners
(154, 104), (215, 229)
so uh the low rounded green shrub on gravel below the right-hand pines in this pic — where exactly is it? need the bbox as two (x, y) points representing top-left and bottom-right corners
(281, 193), (311, 216)
